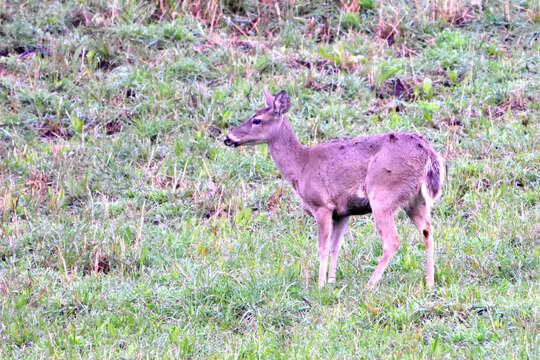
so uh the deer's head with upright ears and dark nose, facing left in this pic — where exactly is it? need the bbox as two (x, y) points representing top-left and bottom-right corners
(225, 90), (291, 147)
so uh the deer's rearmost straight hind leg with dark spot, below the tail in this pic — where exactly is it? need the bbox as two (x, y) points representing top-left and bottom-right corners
(406, 194), (435, 286)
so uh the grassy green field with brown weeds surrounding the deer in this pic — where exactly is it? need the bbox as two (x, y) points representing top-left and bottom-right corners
(0, 0), (540, 359)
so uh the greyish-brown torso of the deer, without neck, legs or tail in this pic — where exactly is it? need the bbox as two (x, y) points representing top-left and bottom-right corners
(298, 133), (433, 214)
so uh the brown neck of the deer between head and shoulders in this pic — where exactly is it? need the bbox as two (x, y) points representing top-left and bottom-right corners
(268, 117), (309, 187)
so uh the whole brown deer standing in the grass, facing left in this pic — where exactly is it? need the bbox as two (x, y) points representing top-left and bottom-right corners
(225, 91), (445, 289)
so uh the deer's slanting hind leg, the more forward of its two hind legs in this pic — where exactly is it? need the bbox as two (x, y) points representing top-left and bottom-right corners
(367, 204), (399, 289)
